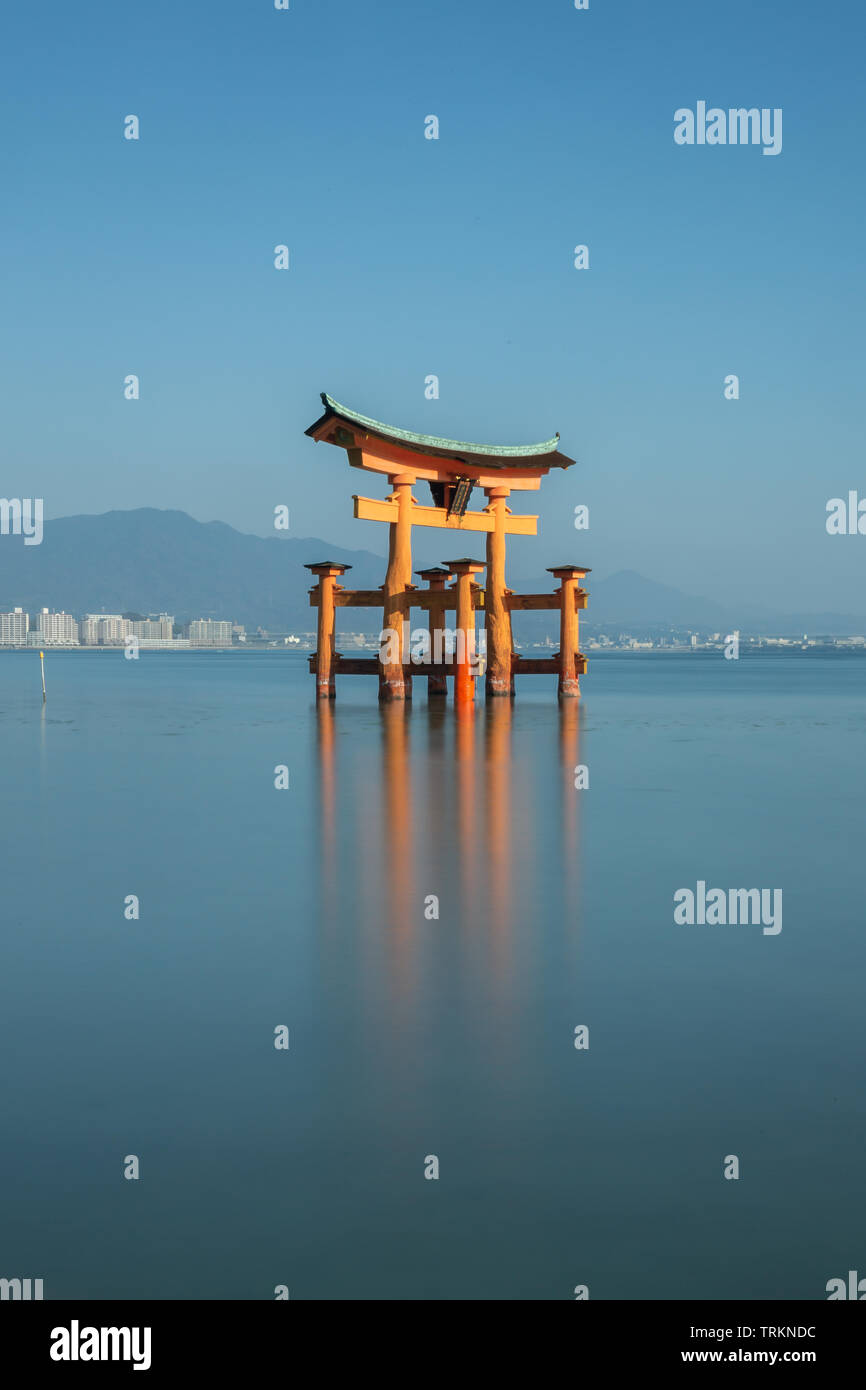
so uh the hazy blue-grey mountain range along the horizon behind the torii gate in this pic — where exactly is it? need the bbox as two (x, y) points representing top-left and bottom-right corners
(0, 507), (866, 637)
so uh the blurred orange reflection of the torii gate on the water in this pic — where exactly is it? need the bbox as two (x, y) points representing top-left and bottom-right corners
(314, 701), (584, 1012)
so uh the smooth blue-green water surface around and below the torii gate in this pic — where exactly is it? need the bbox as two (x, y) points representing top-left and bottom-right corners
(0, 652), (866, 1300)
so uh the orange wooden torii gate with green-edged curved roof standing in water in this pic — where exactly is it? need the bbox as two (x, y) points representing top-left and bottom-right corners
(306, 392), (589, 703)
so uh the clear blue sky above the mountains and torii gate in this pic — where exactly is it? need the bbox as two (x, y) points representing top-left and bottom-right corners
(0, 0), (866, 612)
